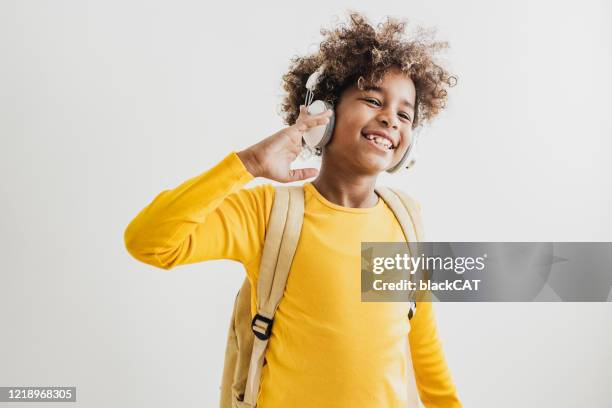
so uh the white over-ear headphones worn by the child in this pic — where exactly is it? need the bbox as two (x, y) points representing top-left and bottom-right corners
(302, 64), (421, 173)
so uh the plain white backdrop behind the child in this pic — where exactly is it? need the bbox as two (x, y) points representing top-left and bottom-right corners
(0, 0), (612, 407)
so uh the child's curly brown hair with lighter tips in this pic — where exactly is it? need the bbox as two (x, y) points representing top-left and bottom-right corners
(281, 12), (457, 134)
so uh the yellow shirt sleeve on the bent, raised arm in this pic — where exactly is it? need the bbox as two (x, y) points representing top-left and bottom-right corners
(124, 152), (274, 270)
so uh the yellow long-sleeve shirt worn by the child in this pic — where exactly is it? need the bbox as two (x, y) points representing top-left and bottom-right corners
(125, 152), (461, 408)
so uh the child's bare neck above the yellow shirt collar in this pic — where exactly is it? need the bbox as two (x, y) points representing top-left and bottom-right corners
(312, 165), (378, 208)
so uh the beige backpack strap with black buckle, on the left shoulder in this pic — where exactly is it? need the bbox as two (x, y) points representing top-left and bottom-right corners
(244, 186), (304, 407)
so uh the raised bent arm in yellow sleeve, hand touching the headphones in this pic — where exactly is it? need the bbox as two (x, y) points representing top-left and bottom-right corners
(124, 106), (331, 269)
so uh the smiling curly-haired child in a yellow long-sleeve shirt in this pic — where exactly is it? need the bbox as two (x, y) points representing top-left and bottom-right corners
(125, 13), (461, 408)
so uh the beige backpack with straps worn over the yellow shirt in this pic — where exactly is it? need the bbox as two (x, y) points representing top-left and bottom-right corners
(220, 186), (424, 408)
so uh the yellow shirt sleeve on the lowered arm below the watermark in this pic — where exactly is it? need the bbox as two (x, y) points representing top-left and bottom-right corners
(408, 302), (461, 408)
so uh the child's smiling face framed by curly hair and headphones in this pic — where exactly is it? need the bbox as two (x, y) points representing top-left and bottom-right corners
(323, 69), (416, 174)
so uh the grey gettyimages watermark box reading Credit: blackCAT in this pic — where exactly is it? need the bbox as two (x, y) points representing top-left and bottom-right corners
(361, 242), (612, 302)
